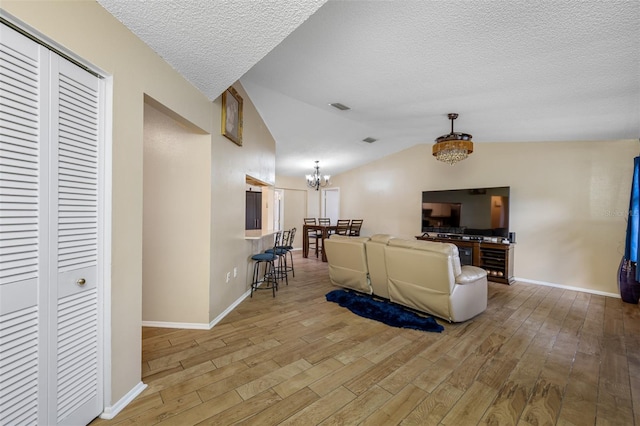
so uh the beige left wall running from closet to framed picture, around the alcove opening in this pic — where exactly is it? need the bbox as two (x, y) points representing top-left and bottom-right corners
(2, 0), (275, 406)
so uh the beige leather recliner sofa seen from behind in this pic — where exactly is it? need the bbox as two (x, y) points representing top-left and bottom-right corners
(325, 234), (487, 322)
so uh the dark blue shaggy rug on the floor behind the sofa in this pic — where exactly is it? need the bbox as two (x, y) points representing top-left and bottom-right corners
(326, 290), (444, 333)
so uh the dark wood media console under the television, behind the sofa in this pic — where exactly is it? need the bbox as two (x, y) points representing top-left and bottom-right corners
(416, 232), (515, 284)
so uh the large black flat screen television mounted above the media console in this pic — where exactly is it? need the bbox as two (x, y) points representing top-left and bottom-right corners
(421, 186), (510, 238)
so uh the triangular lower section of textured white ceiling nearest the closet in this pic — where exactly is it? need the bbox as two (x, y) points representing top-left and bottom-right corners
(98, 0), (326, 100)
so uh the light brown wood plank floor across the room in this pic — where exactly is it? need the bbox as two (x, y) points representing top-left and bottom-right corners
(92, 254), (640, 426)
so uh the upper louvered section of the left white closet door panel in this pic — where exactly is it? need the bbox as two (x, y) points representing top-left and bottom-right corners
(0, 23), (41, 286)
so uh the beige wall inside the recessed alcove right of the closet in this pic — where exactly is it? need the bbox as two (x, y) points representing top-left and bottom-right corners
(142, 103), (211, 324)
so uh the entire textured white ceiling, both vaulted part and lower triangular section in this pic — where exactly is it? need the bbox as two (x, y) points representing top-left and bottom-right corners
(99, 0), (640, 176)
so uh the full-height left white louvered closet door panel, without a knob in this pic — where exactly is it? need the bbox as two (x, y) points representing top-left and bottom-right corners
(0, 25), (48, 424)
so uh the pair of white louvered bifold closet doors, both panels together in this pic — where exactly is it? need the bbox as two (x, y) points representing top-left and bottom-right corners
(0, 25), (102, 425)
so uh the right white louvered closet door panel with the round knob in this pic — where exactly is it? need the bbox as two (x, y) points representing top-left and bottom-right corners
(50, 58), (102, 424)
